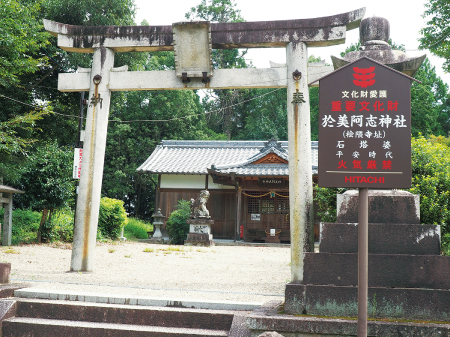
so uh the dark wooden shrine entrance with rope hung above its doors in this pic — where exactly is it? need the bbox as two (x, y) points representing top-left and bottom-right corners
(242, 191), (290, 243)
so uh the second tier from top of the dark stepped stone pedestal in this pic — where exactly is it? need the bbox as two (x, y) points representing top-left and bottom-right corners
(319, 223), (441, 255)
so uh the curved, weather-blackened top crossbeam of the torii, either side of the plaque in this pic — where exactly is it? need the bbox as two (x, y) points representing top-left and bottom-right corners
(44, 8), (365, 53)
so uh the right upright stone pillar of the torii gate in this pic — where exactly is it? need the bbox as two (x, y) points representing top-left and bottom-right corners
(286, 42), (314, 282)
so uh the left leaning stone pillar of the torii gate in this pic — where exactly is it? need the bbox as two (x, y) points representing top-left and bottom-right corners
(70, 47), (114, 272)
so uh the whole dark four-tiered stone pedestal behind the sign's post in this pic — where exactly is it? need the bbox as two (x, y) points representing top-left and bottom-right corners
(284, 191), (450, 322)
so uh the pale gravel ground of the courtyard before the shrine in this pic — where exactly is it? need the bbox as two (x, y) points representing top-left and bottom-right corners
(0, 242), (290, 303)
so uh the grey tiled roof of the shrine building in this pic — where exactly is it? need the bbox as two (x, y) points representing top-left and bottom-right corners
(137, 140), (318, 176)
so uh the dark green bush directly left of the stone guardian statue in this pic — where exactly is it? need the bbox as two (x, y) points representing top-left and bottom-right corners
(166, 199), (191, 245)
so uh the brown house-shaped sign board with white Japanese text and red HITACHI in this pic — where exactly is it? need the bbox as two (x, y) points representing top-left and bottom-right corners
(319, 58), (412, 189)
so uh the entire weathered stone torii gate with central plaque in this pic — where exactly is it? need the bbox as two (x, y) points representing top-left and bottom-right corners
(44, 8), (365, 276)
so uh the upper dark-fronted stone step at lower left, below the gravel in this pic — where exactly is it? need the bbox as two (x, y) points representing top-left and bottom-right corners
(15, 299), (235, 331)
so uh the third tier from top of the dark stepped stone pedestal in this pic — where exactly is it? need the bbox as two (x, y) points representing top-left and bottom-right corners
(303, 253), (450, 289)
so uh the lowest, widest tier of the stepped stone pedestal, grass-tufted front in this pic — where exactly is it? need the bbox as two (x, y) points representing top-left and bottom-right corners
(284, 283), (450, 322)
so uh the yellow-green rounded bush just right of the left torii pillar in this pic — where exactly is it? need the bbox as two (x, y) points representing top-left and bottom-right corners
(97, 198), (127, 240)
